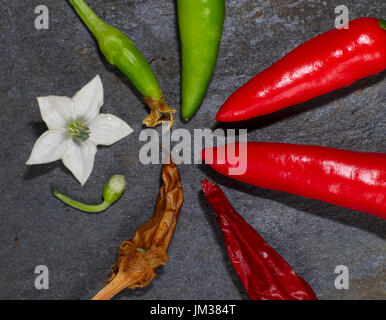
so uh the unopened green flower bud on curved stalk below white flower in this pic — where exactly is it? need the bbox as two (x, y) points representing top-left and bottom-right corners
(52, 175), (126, 213)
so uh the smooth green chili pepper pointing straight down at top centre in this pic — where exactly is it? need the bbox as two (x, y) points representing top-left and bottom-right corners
(177, 0), (225, 121)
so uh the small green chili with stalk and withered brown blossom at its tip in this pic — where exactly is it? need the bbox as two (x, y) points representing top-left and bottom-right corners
(69, 0), (175, 128)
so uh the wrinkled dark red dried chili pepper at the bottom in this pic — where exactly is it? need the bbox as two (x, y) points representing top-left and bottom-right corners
(202, 179), (316, 300)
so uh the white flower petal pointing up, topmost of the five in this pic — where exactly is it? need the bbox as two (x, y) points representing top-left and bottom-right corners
(72, 75), (103, 123)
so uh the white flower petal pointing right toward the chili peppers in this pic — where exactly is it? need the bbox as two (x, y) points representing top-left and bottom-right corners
(89, 114), (133, 146)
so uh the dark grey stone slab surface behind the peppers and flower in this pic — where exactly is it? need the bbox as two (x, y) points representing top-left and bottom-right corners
(0, 0), (386, 299)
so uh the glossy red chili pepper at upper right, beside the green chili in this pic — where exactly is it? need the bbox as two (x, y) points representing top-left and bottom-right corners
(216, 18), (386, 122)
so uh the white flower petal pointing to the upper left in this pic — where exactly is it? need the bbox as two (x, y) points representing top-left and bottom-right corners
(37, 96), (73, 129)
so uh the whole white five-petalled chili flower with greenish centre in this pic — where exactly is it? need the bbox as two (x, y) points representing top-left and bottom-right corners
(27, 75), (133, 185)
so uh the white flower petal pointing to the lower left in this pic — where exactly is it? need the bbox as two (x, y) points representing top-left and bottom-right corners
(27, 130), (70, 165)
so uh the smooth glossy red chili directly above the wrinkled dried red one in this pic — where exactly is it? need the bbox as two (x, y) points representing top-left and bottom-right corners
(202, 142), (386, 219)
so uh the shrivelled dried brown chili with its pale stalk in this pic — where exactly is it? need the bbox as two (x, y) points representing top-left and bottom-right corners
(93, 161), (183, 300)
